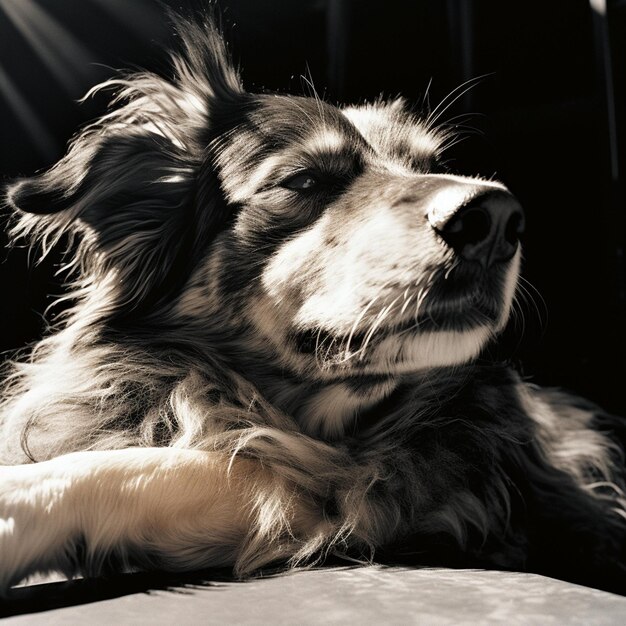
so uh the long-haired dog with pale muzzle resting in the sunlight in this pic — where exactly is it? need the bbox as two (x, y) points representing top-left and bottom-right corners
(0, 15), (626, 592)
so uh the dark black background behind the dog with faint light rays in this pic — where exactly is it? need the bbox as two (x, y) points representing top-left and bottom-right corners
(0, 0), (626, 414)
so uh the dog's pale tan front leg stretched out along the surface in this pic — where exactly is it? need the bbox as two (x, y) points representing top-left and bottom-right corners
(0, 448), (268, 590)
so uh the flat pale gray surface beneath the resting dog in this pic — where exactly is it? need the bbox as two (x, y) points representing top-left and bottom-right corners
(3, 566), (626, 626)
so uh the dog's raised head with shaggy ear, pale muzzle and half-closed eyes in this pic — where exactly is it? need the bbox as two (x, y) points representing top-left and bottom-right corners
(8, 13), (523, 380)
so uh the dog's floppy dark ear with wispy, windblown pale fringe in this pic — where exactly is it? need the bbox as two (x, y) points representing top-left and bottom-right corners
(6, 16), (244, 308)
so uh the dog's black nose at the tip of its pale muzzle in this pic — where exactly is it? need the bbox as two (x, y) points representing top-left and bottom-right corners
(437, 189), (524, 267)
